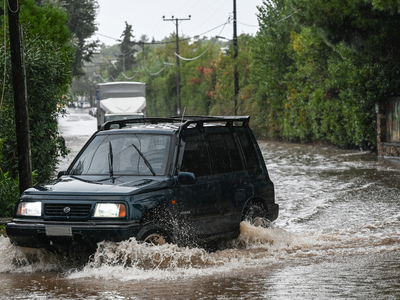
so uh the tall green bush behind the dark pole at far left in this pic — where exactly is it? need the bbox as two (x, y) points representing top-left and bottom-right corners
(0, 0), (74, 182)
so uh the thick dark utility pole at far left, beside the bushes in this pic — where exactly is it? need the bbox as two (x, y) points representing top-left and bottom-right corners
(8, 0), (33, 194)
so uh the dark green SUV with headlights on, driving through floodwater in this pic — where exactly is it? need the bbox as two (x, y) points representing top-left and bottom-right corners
(7, 117), (279, 249)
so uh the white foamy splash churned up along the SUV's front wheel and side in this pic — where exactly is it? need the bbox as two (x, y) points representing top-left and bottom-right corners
(68, 222), (322, 281)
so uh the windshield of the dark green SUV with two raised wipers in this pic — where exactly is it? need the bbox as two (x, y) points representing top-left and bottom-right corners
(69, 133), (171, 176)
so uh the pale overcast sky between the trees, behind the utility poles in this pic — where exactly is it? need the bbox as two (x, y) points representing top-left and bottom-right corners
(95, 0), (262, 45)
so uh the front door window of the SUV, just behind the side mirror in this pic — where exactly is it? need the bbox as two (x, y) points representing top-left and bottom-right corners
(180, 135), (211, 177)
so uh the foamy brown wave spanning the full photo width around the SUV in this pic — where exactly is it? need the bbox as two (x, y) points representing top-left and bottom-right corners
(0, 216), (400, 281)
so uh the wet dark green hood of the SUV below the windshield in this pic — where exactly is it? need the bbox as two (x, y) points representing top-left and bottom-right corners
(24, 176), (175, 196)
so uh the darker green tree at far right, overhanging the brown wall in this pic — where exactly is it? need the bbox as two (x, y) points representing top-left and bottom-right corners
(291, 0), (400, 148)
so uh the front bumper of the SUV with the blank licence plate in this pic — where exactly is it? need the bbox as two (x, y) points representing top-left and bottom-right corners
(6, 219), (140, 249)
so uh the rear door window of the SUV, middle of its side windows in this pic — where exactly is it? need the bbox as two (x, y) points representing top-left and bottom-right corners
(207, 133), (243, 174)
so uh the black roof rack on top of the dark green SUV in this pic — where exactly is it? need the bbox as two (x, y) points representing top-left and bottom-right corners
(100, 116), (250, 131)
